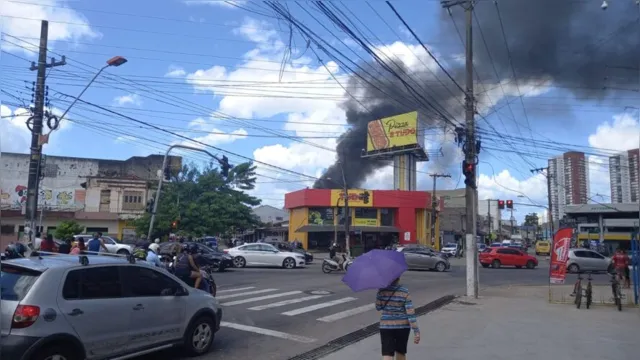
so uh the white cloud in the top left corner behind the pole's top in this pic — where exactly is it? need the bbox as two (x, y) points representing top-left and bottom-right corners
(0, 0), (102, 56)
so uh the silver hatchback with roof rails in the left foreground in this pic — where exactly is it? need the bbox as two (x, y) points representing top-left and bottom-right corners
(0, 255), (222, 360)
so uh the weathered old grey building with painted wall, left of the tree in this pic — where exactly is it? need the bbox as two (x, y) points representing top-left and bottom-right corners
(0, 153), (182, 246)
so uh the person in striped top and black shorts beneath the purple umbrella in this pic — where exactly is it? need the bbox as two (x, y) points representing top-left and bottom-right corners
(376, 278), (420, 360)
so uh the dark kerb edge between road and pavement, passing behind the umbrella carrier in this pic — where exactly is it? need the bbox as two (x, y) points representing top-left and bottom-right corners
(288, 295), (456, 360)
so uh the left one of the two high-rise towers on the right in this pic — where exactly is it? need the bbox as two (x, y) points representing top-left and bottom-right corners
(549, 151), (589, 221)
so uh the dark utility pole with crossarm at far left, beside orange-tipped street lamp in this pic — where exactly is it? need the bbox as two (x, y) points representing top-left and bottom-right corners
(25, 20), (66, 241)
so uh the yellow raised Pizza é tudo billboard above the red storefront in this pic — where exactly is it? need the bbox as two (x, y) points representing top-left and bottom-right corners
(367, 111), (424, 152)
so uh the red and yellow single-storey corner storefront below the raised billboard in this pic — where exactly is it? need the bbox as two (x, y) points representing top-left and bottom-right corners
(285, 189), (443, 255)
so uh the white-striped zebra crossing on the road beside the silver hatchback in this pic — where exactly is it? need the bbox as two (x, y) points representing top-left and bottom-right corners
(216, 286), (375, 323)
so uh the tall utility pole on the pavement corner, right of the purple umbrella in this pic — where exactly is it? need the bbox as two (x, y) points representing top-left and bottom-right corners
(441, 0), (478, 298)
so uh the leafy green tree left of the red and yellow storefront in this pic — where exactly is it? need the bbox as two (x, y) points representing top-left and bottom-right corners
(136, 162), (260, 238)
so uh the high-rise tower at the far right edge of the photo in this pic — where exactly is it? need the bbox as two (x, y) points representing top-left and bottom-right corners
(609, 149), (640, 204)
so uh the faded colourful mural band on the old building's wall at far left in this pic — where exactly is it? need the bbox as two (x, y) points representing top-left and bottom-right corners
(0, 185), (79, 208)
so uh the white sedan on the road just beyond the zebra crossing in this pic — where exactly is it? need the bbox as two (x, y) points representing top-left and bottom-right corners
(224, 243), (306, 269)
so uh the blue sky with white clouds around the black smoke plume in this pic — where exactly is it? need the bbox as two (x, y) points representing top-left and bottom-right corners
(0, 0), (638, 219)
